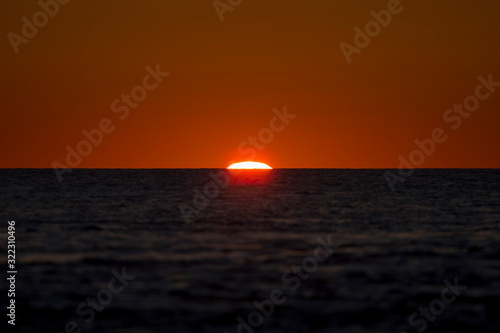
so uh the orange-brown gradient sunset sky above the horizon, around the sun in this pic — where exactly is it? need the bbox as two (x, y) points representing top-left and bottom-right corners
(0, 0), (500, 168)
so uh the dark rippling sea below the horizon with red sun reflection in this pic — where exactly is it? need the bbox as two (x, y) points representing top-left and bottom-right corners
(0, 169), (500, 333)
